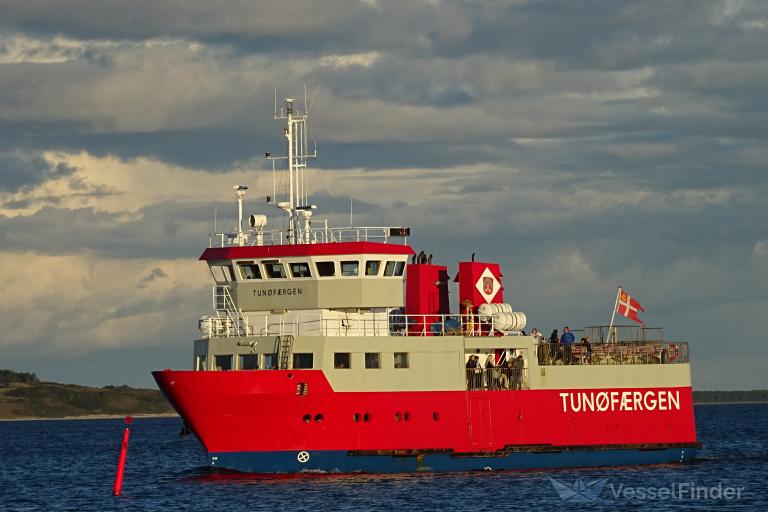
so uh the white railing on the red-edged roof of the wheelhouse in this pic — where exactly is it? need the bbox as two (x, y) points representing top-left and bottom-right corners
(208, 225), (410, 247)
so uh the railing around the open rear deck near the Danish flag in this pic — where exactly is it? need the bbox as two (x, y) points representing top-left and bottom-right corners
(536, 342), (690, 366)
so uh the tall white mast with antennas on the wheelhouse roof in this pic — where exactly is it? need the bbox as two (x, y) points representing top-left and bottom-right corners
(267, 93), (317, 244)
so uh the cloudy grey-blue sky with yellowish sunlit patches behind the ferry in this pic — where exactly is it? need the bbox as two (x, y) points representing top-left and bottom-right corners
(0, 0), (768, 389)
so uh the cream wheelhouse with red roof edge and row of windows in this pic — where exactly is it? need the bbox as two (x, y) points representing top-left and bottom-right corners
(200, 241), (414, 336)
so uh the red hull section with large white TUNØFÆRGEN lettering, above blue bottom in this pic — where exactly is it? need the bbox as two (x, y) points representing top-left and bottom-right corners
(154, 370), (696, 470)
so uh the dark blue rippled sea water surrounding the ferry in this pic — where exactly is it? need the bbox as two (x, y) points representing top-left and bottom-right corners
(0, 404), (768, 512)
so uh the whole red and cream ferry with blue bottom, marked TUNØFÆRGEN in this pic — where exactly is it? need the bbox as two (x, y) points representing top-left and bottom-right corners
(153, 98), (700, 474)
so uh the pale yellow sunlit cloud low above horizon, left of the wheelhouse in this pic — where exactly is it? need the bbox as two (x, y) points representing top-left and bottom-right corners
(0, 251), (207, 354)
